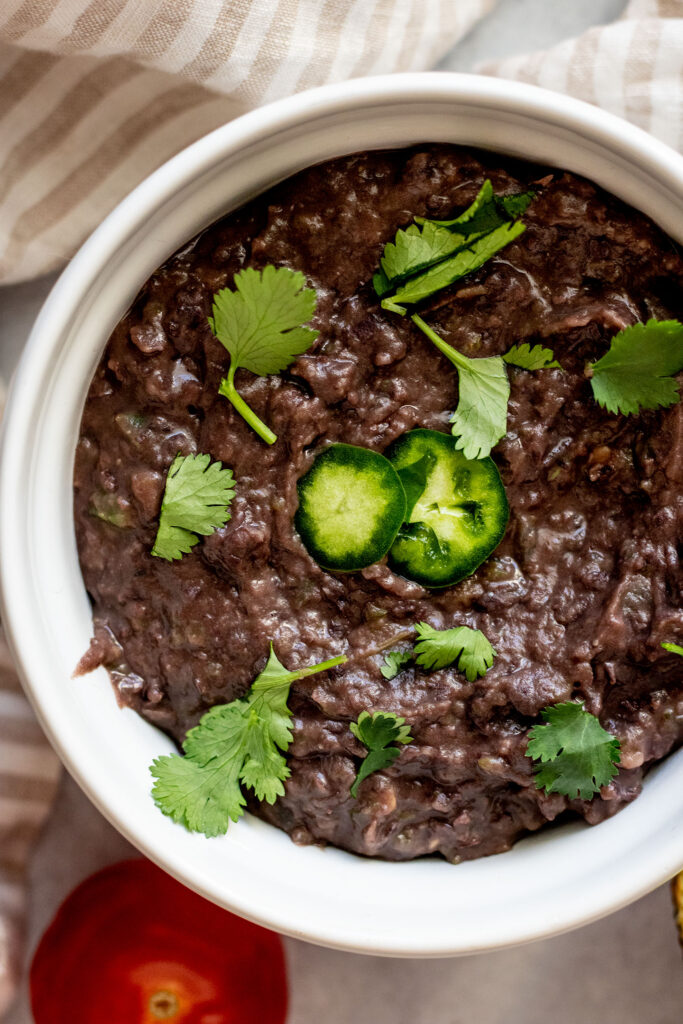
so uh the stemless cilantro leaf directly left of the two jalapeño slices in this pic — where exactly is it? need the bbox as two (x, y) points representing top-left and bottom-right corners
(152, 455), (234, 561)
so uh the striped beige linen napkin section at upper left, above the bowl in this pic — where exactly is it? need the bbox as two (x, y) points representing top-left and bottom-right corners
(0, 0), (496, 284)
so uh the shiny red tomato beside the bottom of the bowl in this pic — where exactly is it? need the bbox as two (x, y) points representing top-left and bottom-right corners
(31, 860), (287, 1024)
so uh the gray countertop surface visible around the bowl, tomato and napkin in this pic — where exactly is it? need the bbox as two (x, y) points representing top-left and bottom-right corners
(0, 0), (683, 1024)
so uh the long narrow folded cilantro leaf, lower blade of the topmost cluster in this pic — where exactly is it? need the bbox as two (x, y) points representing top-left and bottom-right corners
(382, 220), (525, 315)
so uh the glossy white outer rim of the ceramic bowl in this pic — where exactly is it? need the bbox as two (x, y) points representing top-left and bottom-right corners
(0, 72), (683, 956)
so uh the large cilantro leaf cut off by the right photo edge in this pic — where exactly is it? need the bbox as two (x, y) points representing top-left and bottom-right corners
(590, 319), (683, 416)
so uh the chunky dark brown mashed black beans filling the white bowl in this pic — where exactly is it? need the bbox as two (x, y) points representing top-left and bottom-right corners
(75, 145), (683, 861)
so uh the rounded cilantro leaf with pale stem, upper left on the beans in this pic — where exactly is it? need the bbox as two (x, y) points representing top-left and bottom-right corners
(209, 266), (318, 444)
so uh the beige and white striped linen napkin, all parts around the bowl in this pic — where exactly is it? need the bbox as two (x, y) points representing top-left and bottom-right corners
(0, 0), (683, 1015)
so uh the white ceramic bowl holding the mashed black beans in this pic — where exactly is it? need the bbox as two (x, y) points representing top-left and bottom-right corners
(0, 74), (683, 956)
